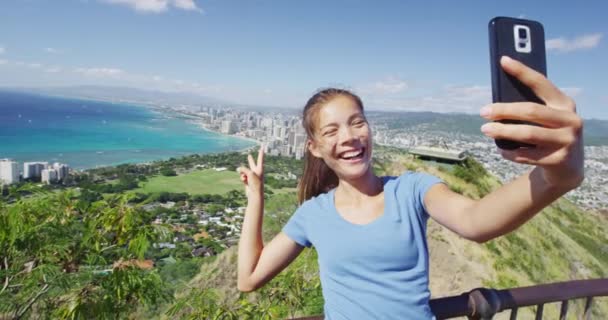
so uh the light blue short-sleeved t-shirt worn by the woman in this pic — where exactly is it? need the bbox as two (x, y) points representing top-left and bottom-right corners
(283, 172), (442, 320)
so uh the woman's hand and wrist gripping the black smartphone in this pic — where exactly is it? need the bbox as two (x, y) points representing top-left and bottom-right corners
(480, 56), (584, 187)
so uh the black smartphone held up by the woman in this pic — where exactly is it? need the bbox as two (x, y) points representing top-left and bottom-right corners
(488, 17), (547, 150)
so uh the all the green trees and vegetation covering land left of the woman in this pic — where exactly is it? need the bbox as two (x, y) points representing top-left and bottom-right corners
(0, 153), (301, 319)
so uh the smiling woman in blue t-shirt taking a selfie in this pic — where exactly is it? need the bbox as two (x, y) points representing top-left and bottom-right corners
(238, 57), (584, 319)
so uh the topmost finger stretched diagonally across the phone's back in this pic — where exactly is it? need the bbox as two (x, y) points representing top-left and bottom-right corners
(500, 56), (576, 111)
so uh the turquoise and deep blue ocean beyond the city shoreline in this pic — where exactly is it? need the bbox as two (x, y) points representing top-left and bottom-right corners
(0, 91), (254, 169)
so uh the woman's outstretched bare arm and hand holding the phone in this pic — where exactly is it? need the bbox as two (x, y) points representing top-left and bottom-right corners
(424, 57), (584, 242)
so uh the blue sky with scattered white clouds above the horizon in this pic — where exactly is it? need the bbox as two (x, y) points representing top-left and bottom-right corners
(0, 0), (608, 119)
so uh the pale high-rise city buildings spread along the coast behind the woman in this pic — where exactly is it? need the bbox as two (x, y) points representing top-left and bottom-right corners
(0, 102), (608, 214)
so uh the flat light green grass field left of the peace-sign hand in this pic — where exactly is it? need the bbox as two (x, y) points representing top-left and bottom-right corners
(134, 169), (243, 195)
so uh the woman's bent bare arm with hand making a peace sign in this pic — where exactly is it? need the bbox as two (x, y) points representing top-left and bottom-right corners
(237, 147), (304, 292)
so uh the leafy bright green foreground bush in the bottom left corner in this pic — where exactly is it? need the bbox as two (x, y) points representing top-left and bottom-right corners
(0, 190), (171, 319)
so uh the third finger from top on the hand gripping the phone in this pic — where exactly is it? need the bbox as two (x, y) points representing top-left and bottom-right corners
(481, 122), (577, 147)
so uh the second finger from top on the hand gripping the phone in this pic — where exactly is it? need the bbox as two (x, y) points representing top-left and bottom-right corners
(480, 102), (582, 128)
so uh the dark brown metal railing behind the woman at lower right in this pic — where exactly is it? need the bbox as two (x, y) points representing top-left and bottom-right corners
(294, 278), (608, 320)
